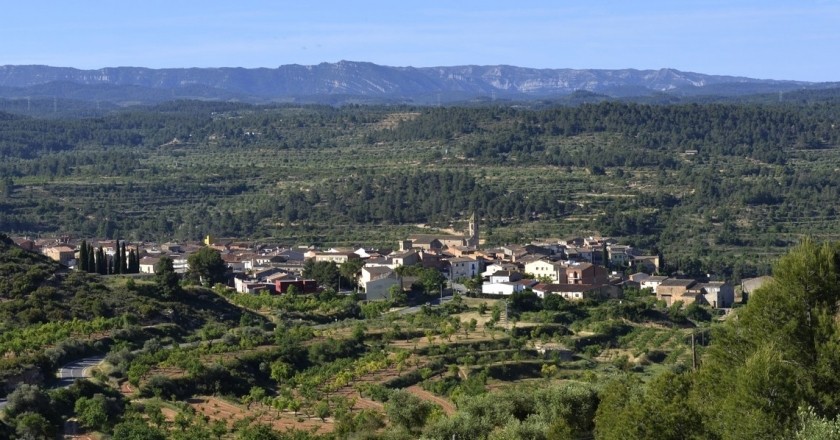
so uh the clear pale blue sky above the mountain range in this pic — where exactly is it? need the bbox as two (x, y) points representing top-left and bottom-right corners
(0, 0), (840, 81)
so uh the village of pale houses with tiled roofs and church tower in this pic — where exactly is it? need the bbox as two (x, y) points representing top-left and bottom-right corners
(14, 215), (767, 311)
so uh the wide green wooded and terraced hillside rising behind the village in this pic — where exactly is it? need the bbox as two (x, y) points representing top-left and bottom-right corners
(0, 99), (840, 278)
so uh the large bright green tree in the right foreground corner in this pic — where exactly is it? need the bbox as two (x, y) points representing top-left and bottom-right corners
(693, 240), (840, 439)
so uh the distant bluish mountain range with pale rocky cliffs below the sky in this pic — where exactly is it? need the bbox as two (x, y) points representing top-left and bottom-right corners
(0, 61), (838, 105)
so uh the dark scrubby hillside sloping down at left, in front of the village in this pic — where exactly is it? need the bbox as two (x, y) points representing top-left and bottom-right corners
(0, 234), (249, 396)
